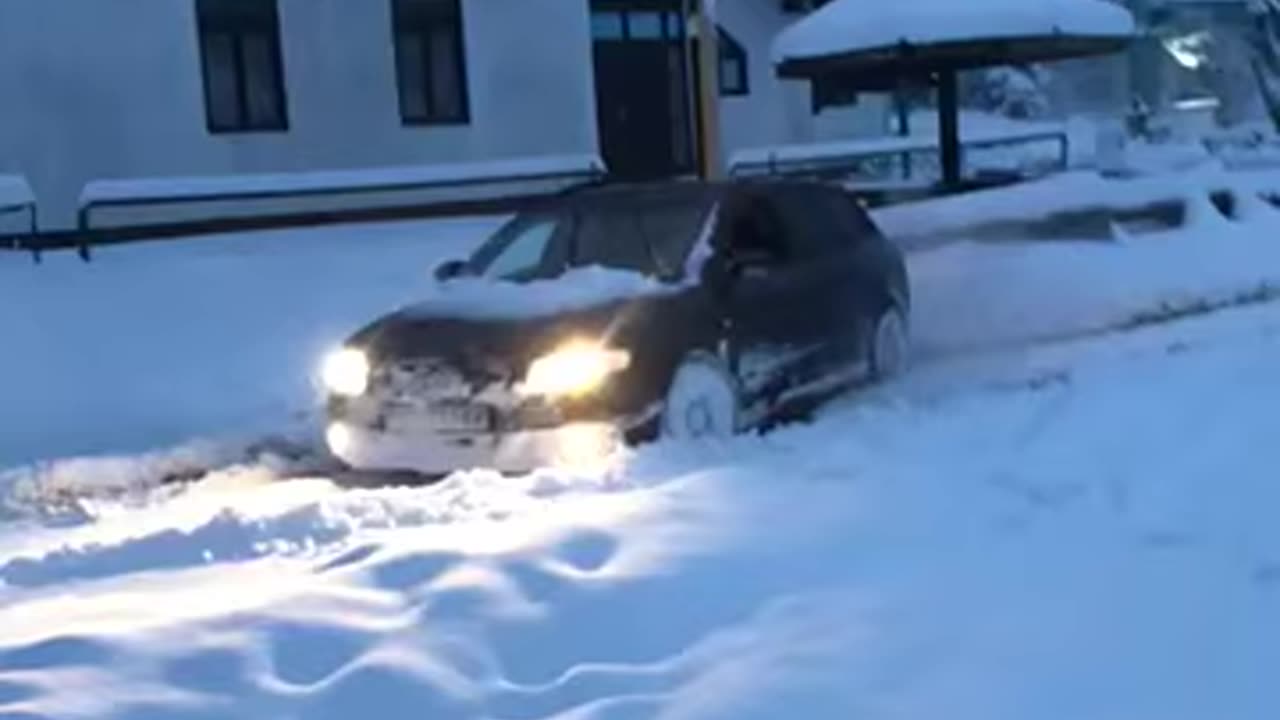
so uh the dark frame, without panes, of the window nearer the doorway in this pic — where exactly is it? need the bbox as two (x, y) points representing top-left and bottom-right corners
(390, 0), (471, 127)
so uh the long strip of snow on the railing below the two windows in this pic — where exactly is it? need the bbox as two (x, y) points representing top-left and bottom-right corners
(81, 155), (604, 206)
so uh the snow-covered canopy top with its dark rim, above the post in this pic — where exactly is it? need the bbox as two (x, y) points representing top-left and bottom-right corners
(773, 0), (1135, 74)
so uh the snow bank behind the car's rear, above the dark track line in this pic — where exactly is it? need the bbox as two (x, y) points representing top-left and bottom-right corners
(909, 188), (1280, 356)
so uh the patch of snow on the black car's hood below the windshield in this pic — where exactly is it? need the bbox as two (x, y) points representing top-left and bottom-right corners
(399, 266), (677, 320)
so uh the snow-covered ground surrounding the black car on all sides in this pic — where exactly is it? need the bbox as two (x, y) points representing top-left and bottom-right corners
(0, 176), (1280, 720)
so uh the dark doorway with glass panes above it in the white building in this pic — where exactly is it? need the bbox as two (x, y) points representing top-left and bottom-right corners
(591, 0), (696, 179)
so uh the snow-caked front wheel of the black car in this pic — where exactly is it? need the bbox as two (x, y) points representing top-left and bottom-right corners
(662, 352), (744, 441)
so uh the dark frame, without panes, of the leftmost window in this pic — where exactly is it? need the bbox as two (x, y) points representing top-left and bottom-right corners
(193, 0), (291, 135)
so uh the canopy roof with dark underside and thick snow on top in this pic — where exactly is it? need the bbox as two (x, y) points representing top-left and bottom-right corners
(773, 0), (1135, 85)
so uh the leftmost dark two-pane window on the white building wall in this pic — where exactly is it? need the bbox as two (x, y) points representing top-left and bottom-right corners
(196, 0), (289, 132)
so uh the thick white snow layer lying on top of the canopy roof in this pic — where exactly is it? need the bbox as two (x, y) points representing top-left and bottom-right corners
(773, 0), (1134, 64)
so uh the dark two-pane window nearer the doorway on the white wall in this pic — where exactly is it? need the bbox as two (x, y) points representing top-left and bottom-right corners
(392, 0), (471, 124)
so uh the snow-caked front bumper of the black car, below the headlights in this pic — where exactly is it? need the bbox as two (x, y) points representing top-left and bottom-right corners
(328, 420), (622, 475)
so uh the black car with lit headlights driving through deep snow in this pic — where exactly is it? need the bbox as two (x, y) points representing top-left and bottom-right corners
(323, 181), (910, 475)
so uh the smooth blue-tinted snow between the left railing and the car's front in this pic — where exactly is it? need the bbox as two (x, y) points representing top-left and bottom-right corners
(0, 218), (504, 468)
